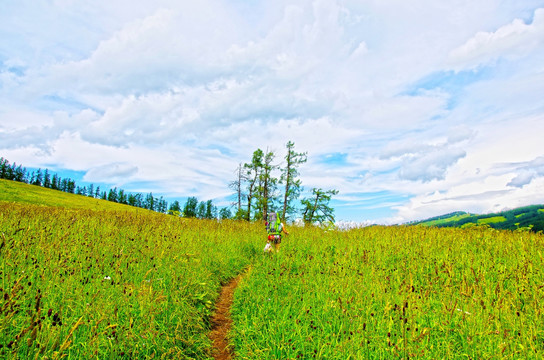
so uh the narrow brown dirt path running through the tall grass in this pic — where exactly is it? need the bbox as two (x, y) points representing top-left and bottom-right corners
(210, 273), (244, 360)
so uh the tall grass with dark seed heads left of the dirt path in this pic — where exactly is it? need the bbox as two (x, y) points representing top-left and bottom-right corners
(0, 202), (261, 359)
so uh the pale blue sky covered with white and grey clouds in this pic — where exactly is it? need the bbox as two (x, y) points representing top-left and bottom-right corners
(0, 0), (544, 224)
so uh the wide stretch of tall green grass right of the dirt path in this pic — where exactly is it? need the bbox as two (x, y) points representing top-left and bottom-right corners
(233, 227), (544, 359)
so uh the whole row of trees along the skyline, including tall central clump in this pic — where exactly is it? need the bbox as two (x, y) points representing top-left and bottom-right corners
(0, 141), (338, 224)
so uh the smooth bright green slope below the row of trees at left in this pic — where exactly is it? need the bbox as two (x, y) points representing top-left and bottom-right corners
(0, 179), (150, 212)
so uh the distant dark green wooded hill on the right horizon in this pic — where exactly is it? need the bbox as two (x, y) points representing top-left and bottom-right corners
(410, 205), (544, 232)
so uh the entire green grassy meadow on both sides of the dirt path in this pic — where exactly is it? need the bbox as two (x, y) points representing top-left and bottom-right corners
(0, 184), (544, 359)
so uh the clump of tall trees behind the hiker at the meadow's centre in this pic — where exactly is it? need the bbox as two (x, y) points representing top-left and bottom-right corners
(229, 141), (338, 224)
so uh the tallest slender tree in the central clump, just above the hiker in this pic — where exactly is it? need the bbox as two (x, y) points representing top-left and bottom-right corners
(280, 141), (308, 220)
